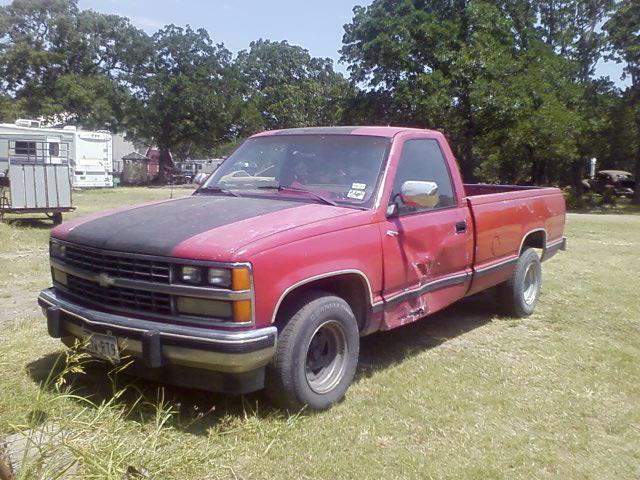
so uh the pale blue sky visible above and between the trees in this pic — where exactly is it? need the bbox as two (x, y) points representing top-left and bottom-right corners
(0, 0), (630, 87)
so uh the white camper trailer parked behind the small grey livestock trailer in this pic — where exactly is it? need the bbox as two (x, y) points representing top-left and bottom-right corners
(0, 120), (113, 188)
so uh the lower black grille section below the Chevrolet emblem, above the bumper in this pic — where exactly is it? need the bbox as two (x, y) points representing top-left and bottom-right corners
(67, 275), (171, 314)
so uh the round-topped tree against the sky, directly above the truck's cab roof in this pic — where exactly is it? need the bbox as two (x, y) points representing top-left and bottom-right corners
(236, 40), (350, 133)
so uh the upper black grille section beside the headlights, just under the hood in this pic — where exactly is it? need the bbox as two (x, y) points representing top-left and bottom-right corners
(65, 245), (170, 283)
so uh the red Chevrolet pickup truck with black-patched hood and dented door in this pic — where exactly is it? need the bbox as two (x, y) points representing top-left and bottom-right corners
(39, 127), (566, 409)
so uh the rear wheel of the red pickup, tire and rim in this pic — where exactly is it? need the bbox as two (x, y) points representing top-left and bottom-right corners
(498, 248), (542, 318)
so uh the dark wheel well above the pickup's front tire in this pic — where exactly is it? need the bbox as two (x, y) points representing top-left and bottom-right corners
(275, 273), (371, 331)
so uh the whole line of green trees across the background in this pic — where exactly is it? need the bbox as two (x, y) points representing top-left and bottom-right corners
(0, 0), (640, 202)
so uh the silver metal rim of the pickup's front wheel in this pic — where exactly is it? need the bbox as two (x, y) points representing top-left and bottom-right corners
(305, 320), (348, 394)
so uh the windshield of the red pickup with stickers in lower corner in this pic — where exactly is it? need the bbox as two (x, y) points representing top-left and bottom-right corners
(202, 135), (390, 207)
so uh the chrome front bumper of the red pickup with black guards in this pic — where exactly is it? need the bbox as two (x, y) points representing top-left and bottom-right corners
(38, 288), (277, 393)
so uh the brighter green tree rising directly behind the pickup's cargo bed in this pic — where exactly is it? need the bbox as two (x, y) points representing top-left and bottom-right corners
(478, 39), (583, 185)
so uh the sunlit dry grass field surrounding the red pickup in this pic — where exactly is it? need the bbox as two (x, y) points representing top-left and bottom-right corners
(0, 189), (640, 479)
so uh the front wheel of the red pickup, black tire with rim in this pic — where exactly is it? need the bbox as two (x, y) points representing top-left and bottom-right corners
(265, 292), (360, 410)
